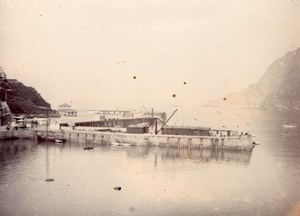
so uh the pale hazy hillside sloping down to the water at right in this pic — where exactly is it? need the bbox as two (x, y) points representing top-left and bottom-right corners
(210, 48), (300, 111)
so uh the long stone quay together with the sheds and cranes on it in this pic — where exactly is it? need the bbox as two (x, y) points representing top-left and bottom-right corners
(0, 68), (253, 150)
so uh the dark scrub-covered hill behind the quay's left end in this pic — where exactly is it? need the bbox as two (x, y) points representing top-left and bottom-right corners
(6, 80), (57, 116)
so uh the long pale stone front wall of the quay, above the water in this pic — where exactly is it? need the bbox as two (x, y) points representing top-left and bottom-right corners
(0, 130), (253, 151)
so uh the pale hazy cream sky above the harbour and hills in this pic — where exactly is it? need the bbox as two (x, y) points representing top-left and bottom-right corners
(0, 0), (300, 108)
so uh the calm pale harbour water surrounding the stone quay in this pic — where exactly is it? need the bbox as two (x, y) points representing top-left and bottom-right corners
(0, 110), (300, 215)
